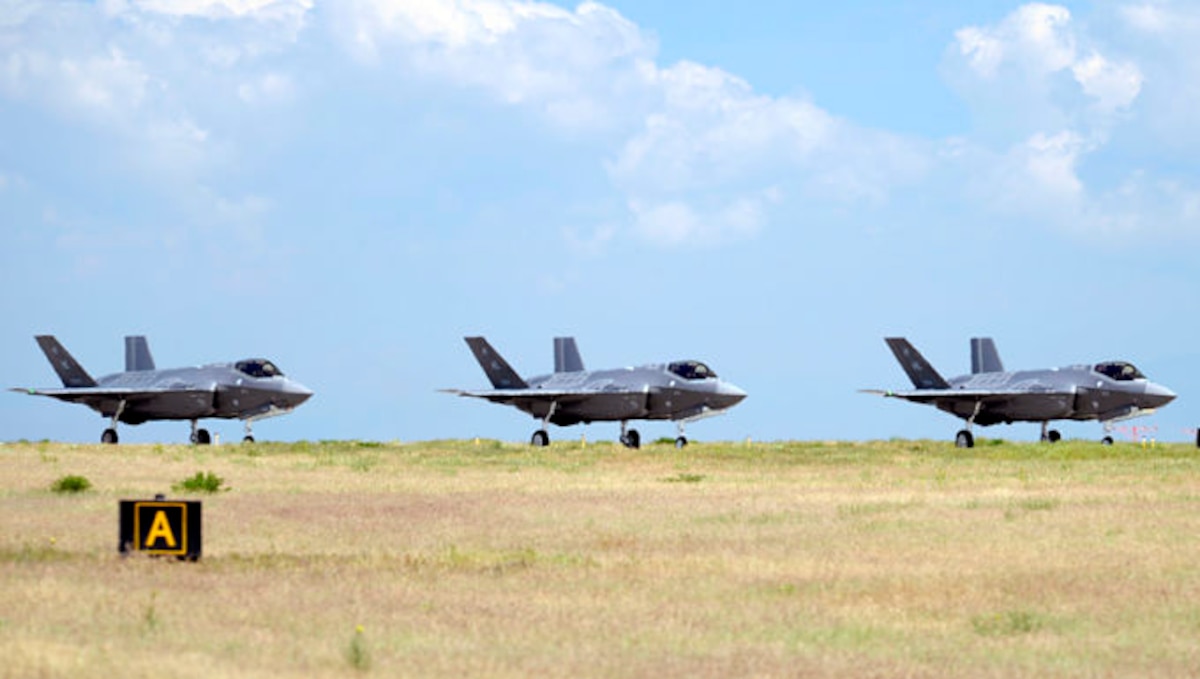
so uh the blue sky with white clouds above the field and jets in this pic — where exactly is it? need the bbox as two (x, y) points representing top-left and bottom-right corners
(0, 0), (1200, 443)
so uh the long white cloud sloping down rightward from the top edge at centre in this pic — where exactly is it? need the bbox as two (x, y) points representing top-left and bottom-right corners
(341, 0), (928, 246)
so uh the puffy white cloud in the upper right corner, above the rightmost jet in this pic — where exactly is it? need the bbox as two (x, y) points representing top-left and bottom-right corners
(946, 4), (1200, 238)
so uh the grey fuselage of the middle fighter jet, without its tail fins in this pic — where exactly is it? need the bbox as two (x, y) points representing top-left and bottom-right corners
(518, 361), (746, 426)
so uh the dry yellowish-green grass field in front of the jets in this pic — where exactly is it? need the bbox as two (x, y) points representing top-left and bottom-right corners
(0, 440), (1200, 678)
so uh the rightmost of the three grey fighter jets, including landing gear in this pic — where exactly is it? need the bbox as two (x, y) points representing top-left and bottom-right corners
(864, 337), (1175, 447)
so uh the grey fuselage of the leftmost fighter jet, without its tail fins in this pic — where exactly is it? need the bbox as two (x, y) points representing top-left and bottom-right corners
(89, 359), (312, 425)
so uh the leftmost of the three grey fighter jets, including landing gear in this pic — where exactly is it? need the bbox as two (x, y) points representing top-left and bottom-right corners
(10, 335), (312, 445)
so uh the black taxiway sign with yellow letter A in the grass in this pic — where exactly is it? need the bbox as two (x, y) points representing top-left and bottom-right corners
(118, 500), (202, 561)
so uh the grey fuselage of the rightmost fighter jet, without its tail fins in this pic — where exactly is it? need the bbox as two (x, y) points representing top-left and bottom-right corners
(936, 361), (1175, 425)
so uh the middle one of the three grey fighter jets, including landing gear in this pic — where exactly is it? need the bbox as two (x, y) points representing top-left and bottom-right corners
(443, 337), (746, 447)
